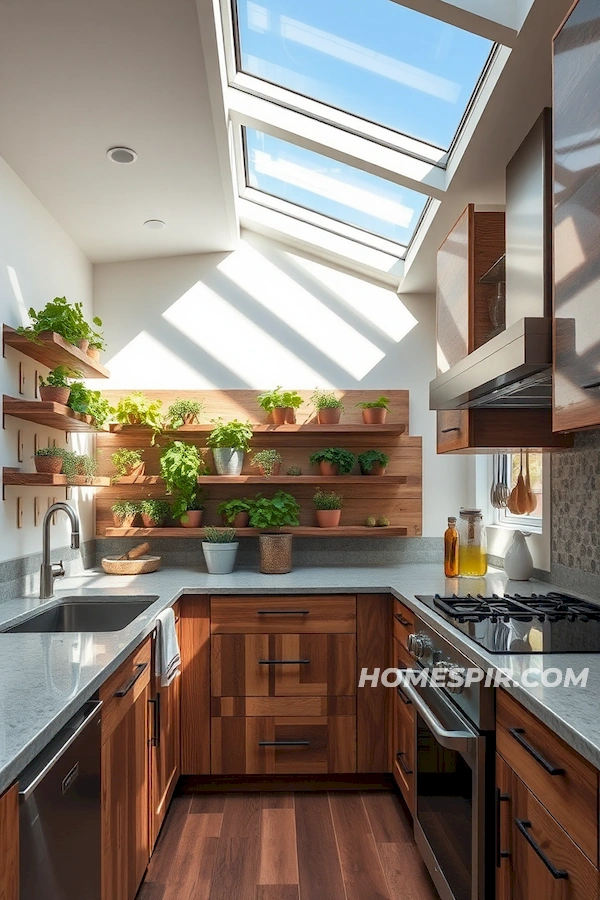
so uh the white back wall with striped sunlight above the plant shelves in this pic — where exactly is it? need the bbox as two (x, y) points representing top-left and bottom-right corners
(94, 233), (467, 536)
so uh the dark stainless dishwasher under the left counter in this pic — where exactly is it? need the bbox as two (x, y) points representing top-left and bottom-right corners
(19, 701), (102, 900)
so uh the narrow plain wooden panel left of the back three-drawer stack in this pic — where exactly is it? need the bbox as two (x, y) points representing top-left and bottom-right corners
(180, 595), (211, 775)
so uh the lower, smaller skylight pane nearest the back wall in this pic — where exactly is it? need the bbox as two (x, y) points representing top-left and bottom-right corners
(245, 128), (427, 244)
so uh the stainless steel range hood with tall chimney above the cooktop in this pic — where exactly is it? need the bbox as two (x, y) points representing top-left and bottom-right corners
(429, 109), (552, 409)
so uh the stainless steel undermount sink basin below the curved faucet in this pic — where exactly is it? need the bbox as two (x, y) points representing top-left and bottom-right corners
(4, 595), (158, 634)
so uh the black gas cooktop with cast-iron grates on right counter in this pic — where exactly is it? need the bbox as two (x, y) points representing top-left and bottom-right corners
(417, 591), (600, 653)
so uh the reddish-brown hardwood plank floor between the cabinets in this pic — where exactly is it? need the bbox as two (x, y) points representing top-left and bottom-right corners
(137, 791), (437, 900)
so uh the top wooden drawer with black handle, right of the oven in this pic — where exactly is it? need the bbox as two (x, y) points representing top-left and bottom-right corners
(496, 691), (598, 865)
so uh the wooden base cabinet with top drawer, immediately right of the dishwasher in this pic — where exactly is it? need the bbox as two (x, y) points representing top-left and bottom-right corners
(100, 639), (151, 900)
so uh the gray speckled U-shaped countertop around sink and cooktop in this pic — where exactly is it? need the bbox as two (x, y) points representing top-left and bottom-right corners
(0, 563), (600, 792)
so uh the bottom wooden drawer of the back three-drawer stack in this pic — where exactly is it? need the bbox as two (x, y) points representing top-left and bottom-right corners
(211, 716), (356, 775)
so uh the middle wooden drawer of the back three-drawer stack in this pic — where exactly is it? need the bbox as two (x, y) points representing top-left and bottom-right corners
(211, 634), (356, 697)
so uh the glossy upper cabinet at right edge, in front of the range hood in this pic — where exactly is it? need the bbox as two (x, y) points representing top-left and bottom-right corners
(553, 0), (600, 430)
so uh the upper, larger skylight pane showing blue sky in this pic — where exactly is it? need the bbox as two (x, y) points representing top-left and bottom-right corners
(233, 0), (492, 149)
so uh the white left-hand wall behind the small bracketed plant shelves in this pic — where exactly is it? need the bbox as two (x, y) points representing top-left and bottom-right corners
(0, 158), (93, 561)
